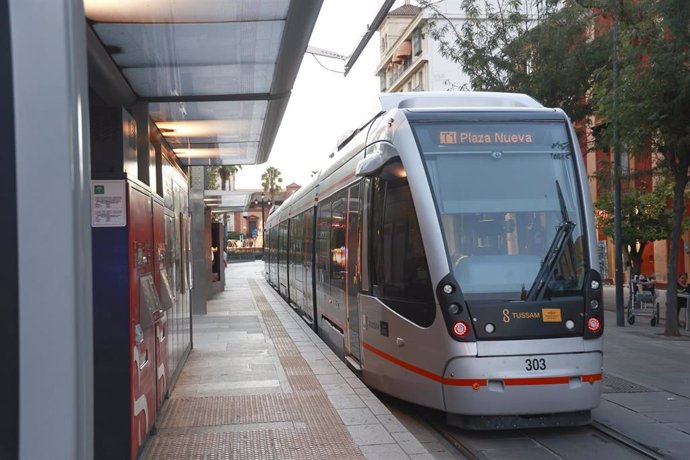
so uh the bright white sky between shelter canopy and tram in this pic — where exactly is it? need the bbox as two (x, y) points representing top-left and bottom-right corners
(235, 0), (404, 190)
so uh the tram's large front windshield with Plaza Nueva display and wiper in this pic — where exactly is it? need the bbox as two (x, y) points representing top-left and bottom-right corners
(413, 121), (587, 300)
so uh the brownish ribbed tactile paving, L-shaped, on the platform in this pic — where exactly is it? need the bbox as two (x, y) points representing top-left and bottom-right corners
(142, 280), (364, 460)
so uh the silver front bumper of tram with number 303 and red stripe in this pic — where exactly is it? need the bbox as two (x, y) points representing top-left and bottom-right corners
(443, 351), (603, 416)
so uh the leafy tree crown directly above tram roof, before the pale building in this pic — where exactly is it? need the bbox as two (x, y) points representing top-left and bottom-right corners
(420, 0), (608, 120)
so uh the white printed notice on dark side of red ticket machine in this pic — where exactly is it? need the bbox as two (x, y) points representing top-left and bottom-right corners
(91, 180), (127, 227)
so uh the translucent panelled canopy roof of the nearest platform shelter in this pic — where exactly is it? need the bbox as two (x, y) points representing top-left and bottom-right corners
(84, 0), (323, 166)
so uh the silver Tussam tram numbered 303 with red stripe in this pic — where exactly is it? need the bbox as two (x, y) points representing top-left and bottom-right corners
(265, 92), (604, 429)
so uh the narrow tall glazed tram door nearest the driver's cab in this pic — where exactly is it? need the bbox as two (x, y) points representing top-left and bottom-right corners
(346, 184), (361, 362)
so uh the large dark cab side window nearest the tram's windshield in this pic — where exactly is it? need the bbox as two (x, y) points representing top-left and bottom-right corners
(371, 163), (436, 327)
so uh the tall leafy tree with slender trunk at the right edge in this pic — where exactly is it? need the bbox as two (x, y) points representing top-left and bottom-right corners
(593, 0), (690, 336)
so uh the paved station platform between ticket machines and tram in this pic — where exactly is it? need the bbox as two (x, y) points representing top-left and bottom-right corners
(142, 262), (433, 460)
